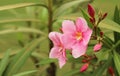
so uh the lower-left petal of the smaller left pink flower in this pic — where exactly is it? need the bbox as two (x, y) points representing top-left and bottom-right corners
(49, 47), (60, 58)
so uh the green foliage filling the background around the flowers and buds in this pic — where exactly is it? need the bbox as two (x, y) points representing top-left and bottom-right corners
(0, 0), (120, 76)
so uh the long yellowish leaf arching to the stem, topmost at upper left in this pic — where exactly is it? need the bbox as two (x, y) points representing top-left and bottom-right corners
(0, 3), (47, 11)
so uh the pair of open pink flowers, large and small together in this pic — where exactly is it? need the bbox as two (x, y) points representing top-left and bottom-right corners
(49, 17), (92, 68)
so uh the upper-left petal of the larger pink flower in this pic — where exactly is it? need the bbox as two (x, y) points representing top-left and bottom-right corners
(62, 20), (75, 33)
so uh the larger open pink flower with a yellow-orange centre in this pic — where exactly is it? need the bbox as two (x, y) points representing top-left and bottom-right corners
(62, 17), (92, 58)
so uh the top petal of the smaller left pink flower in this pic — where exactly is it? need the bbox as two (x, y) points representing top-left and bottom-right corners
(49, 32), (62, 45)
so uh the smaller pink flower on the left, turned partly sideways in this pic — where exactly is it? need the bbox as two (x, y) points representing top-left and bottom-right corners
(49, 32), (67, 68)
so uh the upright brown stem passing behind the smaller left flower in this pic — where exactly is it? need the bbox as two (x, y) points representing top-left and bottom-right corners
(47, 0), (56, 76)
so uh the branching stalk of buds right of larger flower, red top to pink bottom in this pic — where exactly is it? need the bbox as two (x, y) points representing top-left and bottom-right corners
(88, 4), (107, 52)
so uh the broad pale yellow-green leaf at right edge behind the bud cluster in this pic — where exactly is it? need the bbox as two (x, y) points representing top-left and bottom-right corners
(98, 19), (120, 33)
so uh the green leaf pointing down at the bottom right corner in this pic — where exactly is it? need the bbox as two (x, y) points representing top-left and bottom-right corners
(113, 51), (120, 75)
